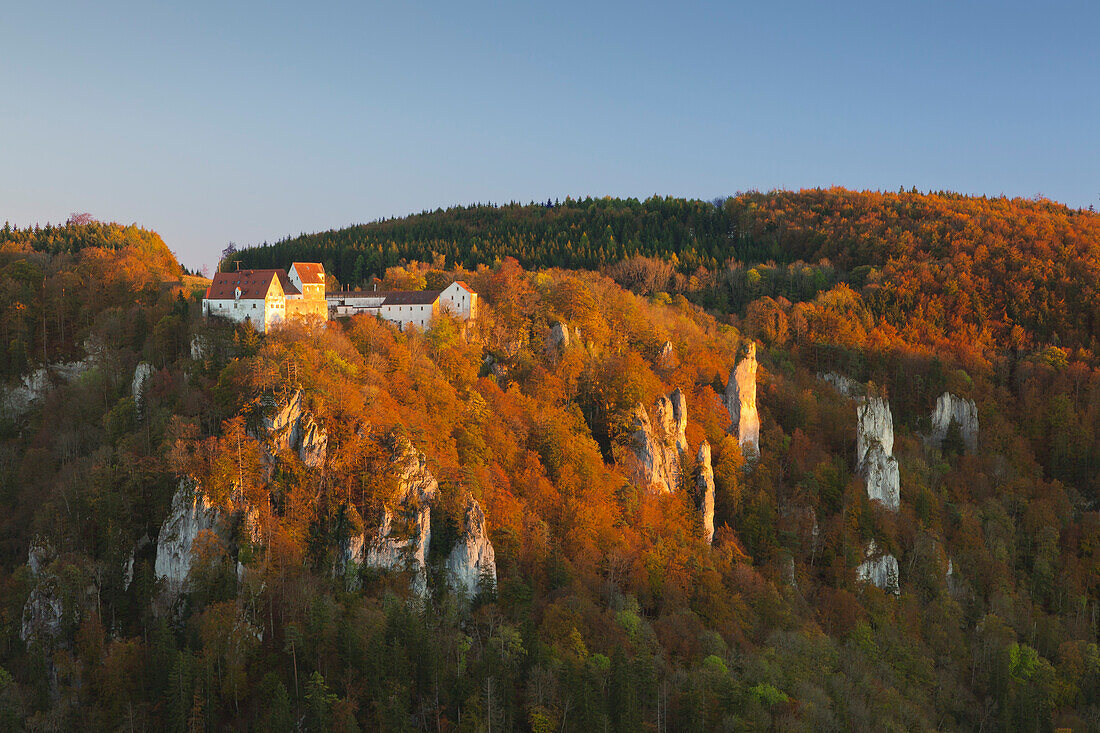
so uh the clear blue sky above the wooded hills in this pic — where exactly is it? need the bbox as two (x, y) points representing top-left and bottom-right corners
(0, 0), (1100, 266)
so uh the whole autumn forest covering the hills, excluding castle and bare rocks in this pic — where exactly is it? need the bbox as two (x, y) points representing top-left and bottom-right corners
(0, 190), (1100, 732)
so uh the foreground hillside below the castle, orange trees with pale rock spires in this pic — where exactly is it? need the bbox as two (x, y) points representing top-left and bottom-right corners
(0, 215), (1100, 731)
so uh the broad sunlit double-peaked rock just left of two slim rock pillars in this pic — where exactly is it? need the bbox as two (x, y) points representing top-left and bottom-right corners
(631, 390), (688, 493)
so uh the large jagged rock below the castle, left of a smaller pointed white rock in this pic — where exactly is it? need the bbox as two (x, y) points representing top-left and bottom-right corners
(348, 442), (439, 595)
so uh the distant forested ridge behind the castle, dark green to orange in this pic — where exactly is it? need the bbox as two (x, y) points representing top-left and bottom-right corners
(227, 188), (1100, 352)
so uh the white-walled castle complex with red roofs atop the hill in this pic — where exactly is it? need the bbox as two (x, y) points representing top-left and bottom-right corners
(202, 262), (477, 332)
